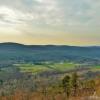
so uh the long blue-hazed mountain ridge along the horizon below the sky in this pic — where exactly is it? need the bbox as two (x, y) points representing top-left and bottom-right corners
(0, 42), (100, 63)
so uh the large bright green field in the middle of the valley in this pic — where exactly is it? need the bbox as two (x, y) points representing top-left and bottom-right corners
(17, 63), (76, 73)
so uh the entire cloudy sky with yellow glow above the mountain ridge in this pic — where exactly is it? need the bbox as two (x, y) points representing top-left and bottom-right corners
(0, 0), (100, 46)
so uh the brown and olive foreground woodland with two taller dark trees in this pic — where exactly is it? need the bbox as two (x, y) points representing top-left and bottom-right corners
(0, 73), (100, 100)
